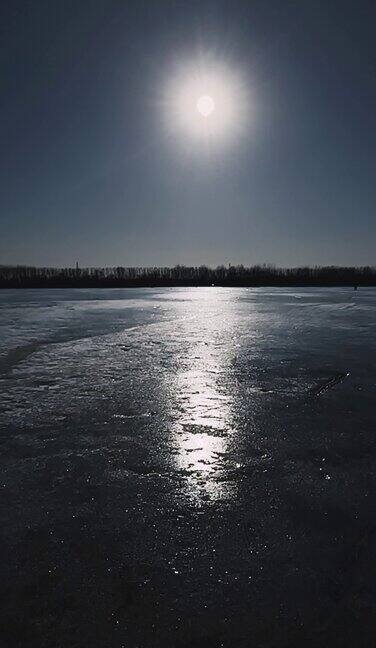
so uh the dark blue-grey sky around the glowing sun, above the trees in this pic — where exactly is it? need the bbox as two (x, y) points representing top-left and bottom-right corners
(0, 0), (376, 266)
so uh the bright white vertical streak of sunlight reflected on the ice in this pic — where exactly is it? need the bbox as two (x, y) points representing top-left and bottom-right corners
(170, 290), (238, 503)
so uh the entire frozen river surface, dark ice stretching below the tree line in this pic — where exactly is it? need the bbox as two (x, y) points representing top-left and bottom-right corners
(0, 288), (376, 648)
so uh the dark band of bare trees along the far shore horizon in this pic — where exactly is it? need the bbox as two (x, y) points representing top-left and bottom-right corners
(0, 264), (376, 288)
